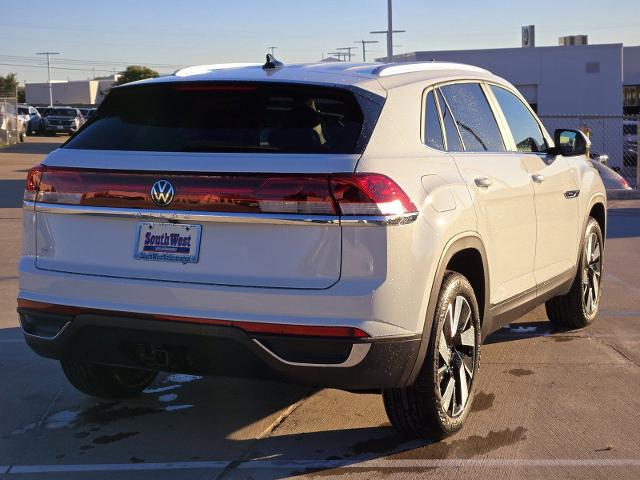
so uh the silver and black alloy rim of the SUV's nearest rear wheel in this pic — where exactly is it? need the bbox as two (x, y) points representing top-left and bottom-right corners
(437, 295), (477, 417)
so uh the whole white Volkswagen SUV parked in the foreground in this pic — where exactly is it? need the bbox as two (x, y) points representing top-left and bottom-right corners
(18, 58), (606, 438)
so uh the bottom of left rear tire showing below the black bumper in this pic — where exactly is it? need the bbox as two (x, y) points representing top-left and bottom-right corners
(60, 360), (158, 398)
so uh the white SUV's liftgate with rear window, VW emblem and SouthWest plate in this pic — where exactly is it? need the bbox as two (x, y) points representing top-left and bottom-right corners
(36, 82), (376, 288)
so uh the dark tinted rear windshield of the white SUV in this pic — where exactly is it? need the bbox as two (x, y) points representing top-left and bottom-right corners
(65, 82), (363, 153)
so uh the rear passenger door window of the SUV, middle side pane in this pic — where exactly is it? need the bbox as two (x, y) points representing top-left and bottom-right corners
(440, 83), (506, 152)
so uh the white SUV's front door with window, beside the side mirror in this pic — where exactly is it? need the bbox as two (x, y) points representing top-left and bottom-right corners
(490, 85), (580, 285)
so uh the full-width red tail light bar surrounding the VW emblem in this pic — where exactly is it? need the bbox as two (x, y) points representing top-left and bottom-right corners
(24, 165), (417, 216)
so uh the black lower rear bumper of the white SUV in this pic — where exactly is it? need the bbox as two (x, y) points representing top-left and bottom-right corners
(18, 308), (420, 390)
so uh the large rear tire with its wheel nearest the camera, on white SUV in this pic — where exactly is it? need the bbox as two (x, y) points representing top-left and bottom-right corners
(382, 272), (481, 440)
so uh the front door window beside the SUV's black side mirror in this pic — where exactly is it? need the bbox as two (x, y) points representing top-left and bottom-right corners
(491, 85), (547, 153)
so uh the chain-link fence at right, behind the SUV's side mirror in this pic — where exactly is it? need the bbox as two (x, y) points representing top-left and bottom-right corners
(540, 115), (640, 185)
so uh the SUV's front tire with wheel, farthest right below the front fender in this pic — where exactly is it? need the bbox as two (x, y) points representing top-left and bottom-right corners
(545, 217), (604, 329)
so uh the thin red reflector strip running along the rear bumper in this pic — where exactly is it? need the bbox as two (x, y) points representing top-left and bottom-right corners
(18, 298), (369, 338)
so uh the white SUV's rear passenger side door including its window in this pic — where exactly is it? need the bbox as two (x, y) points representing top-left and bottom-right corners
(438, 82), (536, 304)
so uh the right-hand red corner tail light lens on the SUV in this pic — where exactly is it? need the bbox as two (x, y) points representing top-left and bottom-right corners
(330, 173), (418, 215)
